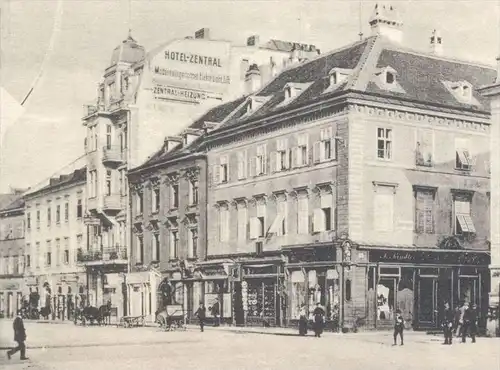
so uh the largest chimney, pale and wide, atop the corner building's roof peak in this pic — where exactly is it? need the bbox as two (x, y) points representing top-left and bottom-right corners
(369, 3), (403, 43)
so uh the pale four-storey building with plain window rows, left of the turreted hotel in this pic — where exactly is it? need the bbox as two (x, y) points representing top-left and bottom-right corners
(24, 168), (87, 320)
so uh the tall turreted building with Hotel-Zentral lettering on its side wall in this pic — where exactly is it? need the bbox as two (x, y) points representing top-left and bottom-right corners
(83, 29), (319, 312)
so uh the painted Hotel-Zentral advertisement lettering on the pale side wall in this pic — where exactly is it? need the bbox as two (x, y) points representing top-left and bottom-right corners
(149, 39), (231, 104)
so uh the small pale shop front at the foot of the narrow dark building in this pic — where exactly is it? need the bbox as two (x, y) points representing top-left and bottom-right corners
(126, 270), (161, 322)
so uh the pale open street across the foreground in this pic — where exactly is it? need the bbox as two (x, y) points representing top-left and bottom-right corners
(0, 320), (500, 370)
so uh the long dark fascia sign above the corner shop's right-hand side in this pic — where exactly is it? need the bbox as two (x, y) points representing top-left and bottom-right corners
(370, 250), (490, 266)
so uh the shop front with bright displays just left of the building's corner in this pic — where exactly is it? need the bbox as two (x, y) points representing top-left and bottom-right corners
(283, 243), (342, 330)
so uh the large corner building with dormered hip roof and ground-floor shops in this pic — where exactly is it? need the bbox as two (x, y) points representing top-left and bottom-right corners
(201, 6), (495, 329)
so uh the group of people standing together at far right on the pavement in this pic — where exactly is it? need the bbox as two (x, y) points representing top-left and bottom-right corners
(443, 302), (478, 344)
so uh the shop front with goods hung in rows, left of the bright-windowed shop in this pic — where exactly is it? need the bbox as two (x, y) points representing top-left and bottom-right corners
(238, 257), (286, 326)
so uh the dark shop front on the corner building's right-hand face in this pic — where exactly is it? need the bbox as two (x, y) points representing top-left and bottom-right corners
(359, 246), (490, 330)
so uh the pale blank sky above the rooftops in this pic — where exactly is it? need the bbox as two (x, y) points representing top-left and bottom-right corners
(0, 0), (500, 192)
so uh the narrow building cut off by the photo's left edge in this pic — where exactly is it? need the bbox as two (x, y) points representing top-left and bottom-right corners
(0, 194), (25, 317)
